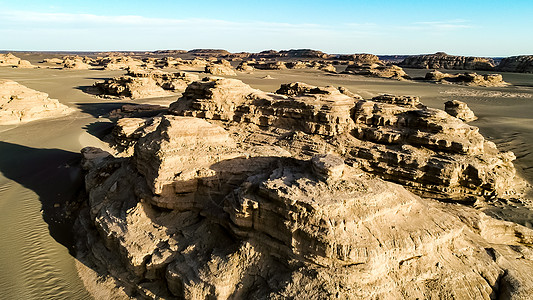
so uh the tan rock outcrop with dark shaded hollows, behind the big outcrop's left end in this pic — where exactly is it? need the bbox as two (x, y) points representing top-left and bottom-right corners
(94, 70), (199, 99)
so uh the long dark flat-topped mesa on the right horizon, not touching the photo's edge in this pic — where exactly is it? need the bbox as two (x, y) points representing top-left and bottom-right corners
(399, 52), (494, 71)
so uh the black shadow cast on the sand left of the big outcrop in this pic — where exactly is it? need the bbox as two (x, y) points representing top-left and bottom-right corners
(0, 141), (84, 254)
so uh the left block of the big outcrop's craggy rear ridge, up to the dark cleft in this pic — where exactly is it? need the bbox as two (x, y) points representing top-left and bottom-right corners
(169, 78), (360, 135)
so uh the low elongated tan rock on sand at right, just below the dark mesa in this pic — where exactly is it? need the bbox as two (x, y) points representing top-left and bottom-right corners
(425, 70), (509, 87)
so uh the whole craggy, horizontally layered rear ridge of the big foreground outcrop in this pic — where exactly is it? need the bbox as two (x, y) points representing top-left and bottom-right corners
(165, 78), (516, 201)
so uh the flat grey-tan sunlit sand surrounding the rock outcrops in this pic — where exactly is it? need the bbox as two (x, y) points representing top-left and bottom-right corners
(0, 61), (533, 299)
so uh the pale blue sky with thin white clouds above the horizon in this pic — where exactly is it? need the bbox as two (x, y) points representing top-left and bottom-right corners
(0, 0), (533, 56)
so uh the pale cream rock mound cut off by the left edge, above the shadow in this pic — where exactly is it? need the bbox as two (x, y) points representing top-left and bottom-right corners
(0, 80), (73, 125)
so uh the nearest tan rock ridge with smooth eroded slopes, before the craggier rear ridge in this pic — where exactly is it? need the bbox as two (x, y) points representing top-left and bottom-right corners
(77, 105), (533, 299)
